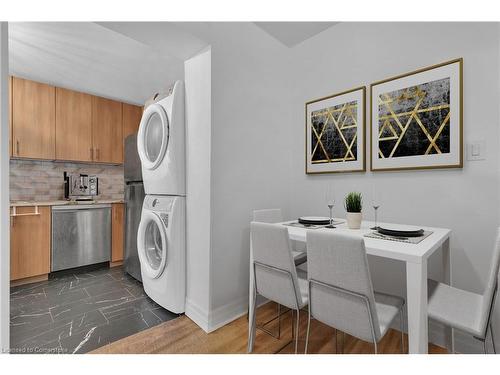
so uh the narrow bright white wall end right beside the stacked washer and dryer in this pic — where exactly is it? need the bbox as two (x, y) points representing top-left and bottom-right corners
(184, 48), (212, 331)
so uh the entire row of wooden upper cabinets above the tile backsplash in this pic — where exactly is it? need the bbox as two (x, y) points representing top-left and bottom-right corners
(9, 77), (129, 164)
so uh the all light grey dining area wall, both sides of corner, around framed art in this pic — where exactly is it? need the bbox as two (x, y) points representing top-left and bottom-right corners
(178, 23), (500, 352)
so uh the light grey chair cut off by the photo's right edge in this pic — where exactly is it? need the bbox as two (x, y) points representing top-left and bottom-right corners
(427, 228), (500, 354)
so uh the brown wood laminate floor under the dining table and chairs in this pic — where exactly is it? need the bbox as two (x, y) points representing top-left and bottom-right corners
(92, 303), (446, 354)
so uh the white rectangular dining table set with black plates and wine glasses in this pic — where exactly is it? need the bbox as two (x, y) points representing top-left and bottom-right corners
(248, 218), (454, 354)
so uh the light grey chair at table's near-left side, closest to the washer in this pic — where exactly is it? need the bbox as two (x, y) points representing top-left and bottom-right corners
(250, 222), (308, 353)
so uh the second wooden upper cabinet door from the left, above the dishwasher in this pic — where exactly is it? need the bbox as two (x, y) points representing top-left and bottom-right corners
(56, 87), (93, 161)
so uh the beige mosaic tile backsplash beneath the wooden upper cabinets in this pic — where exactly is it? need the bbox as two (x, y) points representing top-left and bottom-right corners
(10, 160), (124, 201)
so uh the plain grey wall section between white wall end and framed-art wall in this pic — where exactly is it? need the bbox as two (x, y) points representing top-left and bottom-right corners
(181, 23), (291, 331)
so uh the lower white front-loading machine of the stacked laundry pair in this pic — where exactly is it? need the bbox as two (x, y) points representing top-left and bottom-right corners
(137, 195), (186, 314)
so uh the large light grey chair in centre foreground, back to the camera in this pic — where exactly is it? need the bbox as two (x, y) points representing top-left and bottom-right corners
(305, 230), (405, 353)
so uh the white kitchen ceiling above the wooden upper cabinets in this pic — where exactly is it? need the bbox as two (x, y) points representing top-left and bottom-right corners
(9, 22), (186, 104)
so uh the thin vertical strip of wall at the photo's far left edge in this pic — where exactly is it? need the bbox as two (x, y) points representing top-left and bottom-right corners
(0, 22), (10, 353)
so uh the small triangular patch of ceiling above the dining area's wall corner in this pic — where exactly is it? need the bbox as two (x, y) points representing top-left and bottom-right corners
(254, 22), (338, 47)
